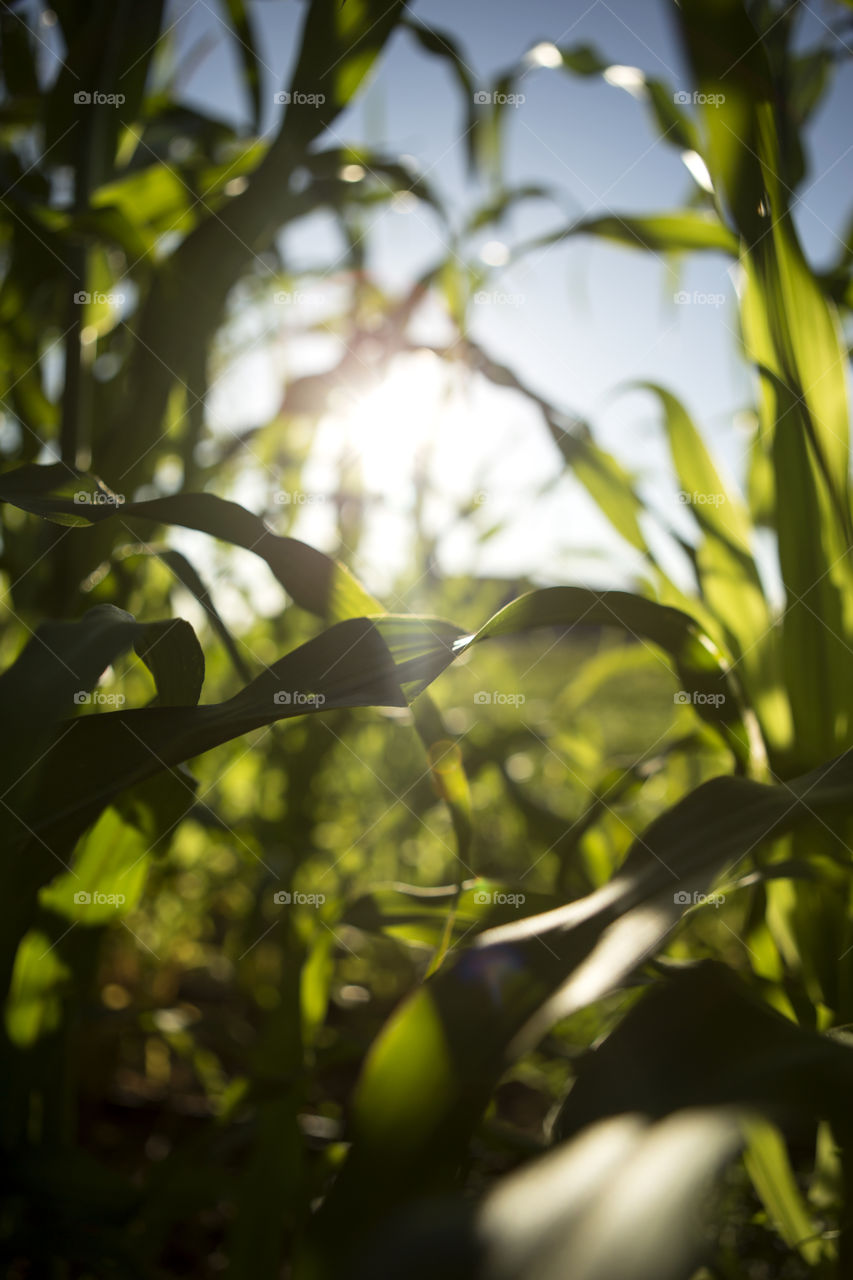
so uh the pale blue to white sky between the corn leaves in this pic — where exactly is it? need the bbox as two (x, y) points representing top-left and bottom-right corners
(162, 0), (853, 599)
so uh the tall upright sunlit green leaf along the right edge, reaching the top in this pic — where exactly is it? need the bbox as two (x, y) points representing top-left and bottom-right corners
(680, 0), (853, 762)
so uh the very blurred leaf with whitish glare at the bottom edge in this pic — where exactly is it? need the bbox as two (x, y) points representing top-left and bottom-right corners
(353, 1110), (743, 1280)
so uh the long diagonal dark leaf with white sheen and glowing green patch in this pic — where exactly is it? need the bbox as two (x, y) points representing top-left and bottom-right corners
(313, 753), (853, 1247)
